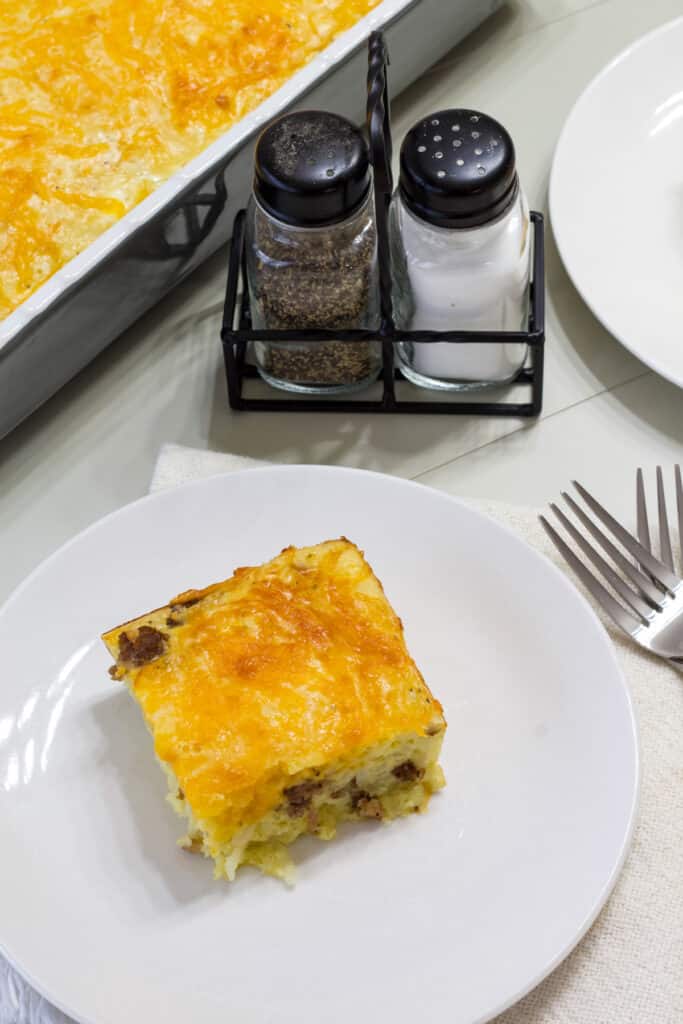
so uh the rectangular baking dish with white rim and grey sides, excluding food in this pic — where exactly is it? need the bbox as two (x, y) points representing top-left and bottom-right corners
(0, 0), (501, 437)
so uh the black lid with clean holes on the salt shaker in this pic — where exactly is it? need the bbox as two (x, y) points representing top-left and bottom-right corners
(399, 110), (517, 227)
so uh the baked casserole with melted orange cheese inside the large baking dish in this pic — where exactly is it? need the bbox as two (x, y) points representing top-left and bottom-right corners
(0, 0), (379, 319)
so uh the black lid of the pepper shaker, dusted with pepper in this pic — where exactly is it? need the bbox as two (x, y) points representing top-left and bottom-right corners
(254, 111), (371, 226)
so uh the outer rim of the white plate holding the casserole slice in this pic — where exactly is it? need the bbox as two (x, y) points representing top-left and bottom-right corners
(0, 466), (643, 1024)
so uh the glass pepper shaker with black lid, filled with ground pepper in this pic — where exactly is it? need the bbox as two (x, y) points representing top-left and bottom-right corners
(246, 111), (382, 394)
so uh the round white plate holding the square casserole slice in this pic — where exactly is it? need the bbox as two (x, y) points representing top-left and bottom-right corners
(0, 467), (638, 1024)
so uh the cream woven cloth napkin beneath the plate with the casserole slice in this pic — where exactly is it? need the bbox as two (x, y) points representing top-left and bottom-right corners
(6, 444), (683, 1024)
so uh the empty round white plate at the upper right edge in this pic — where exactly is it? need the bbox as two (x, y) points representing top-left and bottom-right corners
(550, 18), (683, 387)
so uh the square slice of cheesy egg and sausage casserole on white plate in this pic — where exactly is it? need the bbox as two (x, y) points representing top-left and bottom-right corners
(103, 539), (445, 881)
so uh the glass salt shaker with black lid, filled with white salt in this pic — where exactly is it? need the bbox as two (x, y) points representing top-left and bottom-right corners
(389, 110), (530, 391)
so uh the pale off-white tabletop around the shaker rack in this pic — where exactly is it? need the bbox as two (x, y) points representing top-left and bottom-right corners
(0, 0), (683, 600)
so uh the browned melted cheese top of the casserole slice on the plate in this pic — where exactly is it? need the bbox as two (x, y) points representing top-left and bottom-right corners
(103, 540), (443, 830)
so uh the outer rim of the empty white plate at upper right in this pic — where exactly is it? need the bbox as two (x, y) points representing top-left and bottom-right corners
(548, 14), (683, 388)
